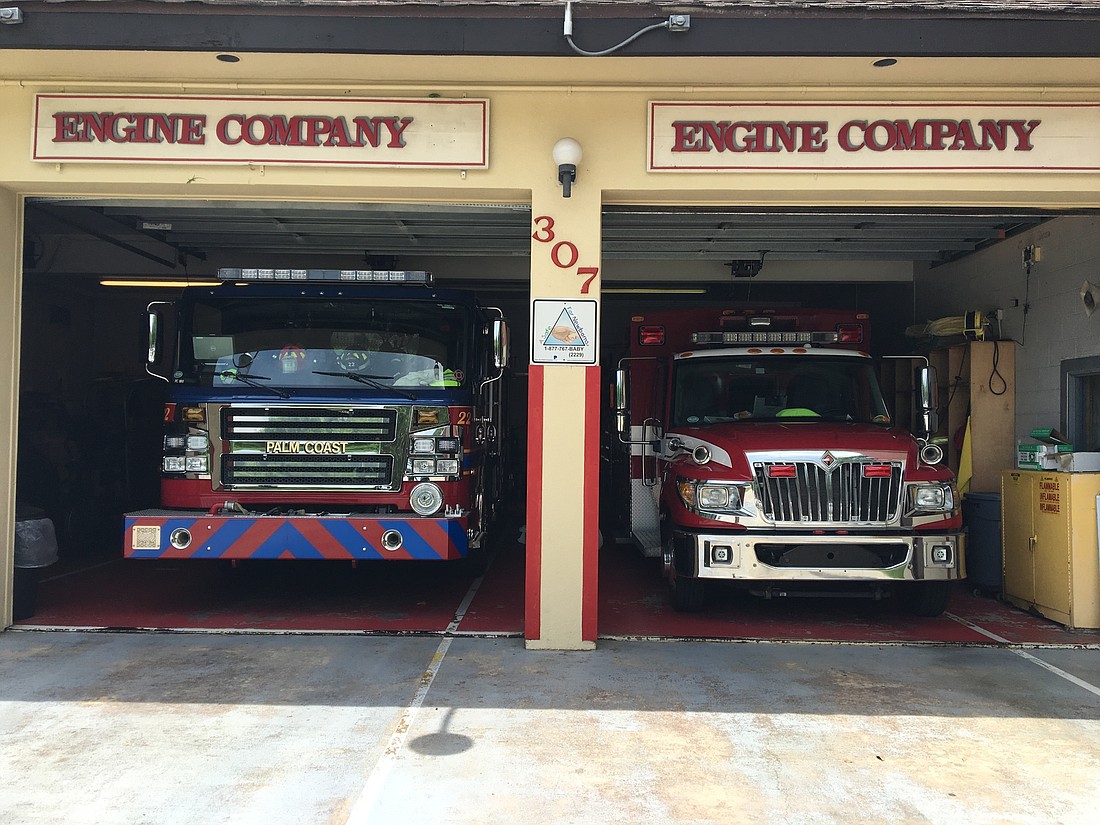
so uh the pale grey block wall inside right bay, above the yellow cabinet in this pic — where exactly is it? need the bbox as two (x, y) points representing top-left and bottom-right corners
(915, 216), (1100, 439)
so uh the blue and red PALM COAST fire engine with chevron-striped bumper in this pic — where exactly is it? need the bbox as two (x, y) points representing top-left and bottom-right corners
(124, 268), (508, 562)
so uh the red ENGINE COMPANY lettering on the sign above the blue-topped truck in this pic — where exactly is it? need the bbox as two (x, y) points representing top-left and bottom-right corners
(53, 112), (414, 149)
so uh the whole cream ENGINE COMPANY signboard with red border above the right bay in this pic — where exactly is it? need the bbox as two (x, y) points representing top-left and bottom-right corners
(648, 101), (1100, 172)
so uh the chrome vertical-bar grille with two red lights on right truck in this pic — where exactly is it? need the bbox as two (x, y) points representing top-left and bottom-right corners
(752, 461), (902, 525)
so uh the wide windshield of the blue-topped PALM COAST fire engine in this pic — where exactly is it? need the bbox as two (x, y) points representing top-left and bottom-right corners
(180, 296), (472, 393)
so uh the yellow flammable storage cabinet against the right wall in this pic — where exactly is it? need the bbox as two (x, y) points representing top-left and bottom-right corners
(1001, 470), (1100, 628)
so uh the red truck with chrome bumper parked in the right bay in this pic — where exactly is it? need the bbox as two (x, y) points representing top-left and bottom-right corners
(615, 309), (965, 616)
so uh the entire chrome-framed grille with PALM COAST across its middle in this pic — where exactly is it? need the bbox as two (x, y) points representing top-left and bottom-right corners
(221, 407), (404, 490)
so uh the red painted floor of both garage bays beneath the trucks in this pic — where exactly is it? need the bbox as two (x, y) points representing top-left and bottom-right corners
(17, 536), (1100, 645)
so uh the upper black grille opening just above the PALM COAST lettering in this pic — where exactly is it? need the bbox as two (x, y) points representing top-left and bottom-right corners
(221, 407), (397, 442)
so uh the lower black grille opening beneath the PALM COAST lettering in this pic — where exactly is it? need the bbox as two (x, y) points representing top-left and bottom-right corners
(221, 453), (394, 487)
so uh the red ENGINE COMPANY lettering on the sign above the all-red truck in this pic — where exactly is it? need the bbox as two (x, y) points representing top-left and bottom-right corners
(672, 119), (1042, 153)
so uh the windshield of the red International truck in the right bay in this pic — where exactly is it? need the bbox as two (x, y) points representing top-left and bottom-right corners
(670, 355), (890, 427)
